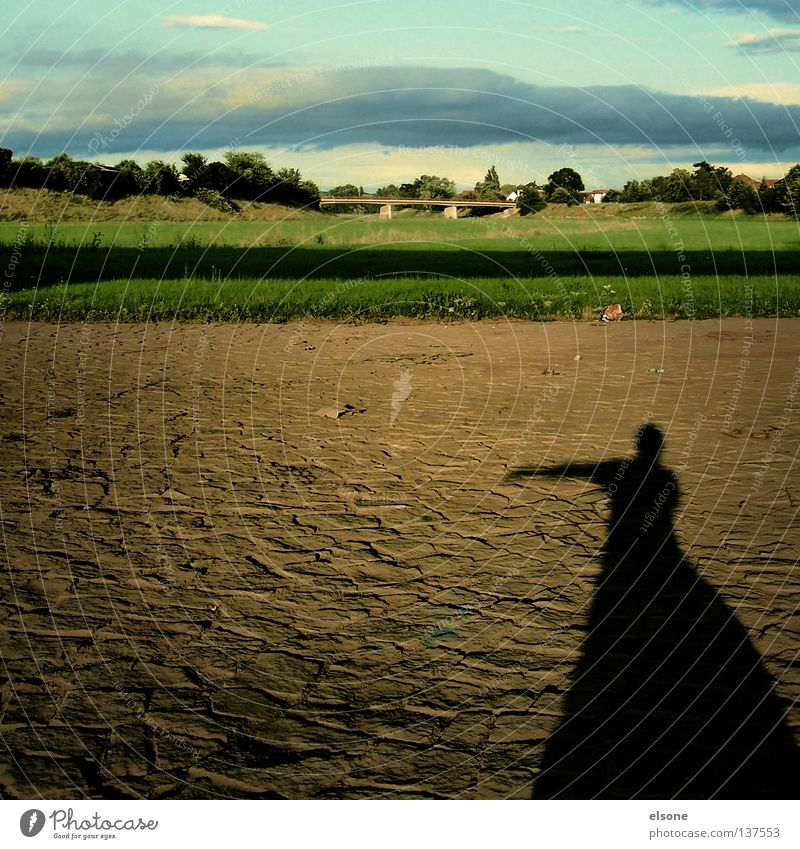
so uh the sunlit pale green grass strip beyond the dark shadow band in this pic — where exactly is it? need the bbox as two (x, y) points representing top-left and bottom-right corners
(0, 211), (800, 252)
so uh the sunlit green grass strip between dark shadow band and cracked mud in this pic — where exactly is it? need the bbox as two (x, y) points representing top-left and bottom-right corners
(3, 276), (800, 322)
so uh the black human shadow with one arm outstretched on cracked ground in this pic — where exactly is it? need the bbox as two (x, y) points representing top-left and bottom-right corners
(510, 425), (800, 799)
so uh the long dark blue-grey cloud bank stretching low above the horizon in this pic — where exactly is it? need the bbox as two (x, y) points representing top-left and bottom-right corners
(6, 67), (800, 153)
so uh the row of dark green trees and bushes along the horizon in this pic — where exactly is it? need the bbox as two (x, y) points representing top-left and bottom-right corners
(0, 148), (800, 217)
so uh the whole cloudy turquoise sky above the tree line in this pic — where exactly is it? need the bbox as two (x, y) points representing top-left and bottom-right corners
(0, 0), (800, 190)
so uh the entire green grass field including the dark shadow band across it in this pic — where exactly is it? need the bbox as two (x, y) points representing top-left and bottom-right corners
(0, 197), (800, 321)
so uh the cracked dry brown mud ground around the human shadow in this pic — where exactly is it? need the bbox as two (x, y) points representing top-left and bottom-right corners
(0, 319), (800, 798)
